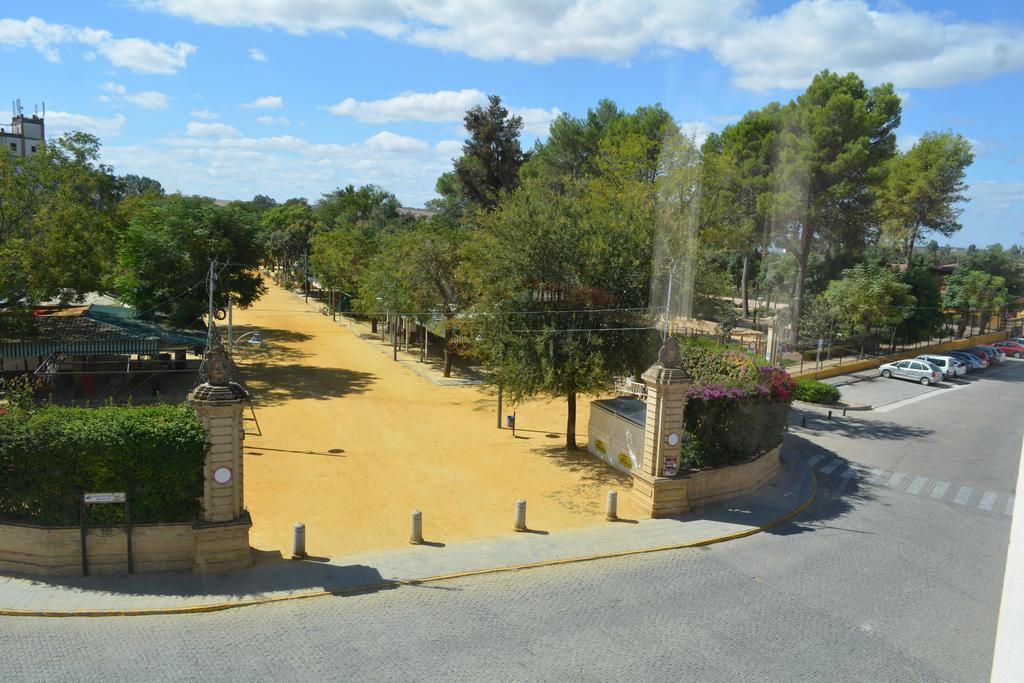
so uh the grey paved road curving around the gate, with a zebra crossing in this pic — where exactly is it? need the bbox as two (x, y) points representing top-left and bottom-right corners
(0, 362), (1024, 681)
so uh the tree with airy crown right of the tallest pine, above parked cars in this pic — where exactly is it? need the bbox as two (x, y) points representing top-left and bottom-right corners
(879, 132), (974, 268)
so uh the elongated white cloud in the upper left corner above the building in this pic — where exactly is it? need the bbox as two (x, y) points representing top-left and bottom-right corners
(0, 16), (196, 74)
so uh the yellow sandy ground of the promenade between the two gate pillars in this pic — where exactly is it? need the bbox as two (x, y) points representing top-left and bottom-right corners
(234, 284), (630, 557)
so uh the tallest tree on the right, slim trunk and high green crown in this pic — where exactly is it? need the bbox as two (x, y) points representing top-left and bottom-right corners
(772, 71), (900, 343)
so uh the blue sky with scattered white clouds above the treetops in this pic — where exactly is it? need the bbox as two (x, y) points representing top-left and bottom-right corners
(0, 0), (1024, 245)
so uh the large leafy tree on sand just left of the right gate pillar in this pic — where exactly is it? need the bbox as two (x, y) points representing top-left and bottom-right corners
(466, 139), (654, 450)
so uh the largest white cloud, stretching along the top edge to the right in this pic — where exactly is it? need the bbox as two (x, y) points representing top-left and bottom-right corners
(134, 0), (1024, 90)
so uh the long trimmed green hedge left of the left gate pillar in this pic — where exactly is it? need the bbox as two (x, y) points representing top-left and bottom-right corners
(0, 405), (206, 524)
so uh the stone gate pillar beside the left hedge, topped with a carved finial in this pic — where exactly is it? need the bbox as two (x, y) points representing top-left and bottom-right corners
(188, 348), (248, 522)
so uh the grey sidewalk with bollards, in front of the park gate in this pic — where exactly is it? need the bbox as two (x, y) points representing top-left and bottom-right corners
(0, 455), (815, 616)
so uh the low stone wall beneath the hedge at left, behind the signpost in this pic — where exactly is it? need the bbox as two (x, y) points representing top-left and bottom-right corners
(0, 513), (252, 577)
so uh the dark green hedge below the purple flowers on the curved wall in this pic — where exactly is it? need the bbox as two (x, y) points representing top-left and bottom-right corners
(683, 397), (790, 468)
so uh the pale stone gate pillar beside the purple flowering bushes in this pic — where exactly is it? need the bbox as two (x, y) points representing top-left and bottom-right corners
(632, 336), (692, 517)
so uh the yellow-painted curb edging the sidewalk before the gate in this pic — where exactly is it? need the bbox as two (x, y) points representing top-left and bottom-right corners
(0, 467), (818, 617)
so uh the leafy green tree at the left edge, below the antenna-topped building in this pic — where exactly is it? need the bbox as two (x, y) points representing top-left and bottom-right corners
(0, 133), (120, 304)
